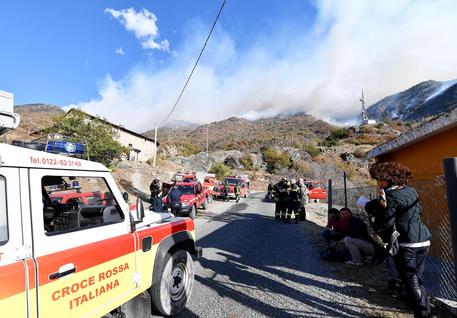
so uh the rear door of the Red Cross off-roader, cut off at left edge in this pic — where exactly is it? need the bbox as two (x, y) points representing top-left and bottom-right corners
(0, 167), (29, 317)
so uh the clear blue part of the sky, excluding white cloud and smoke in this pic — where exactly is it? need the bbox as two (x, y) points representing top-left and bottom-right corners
(0, 0), (313, 106)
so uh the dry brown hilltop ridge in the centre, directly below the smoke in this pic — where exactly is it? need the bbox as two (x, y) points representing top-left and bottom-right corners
(145, 113), (334, 152)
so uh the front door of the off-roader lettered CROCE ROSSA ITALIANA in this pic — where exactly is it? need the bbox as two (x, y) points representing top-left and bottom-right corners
(30, 169), (139, 317)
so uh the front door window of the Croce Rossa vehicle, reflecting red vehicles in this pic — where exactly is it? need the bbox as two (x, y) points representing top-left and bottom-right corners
(41, 176), (124, 235)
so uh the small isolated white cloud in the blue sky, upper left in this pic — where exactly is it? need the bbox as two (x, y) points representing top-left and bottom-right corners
(105, 8), (170, 52)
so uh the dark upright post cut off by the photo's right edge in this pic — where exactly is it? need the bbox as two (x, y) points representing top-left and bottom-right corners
(443, 158), (457, 279)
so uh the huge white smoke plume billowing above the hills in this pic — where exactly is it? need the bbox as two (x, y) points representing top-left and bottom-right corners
(75, 0), (457, 131)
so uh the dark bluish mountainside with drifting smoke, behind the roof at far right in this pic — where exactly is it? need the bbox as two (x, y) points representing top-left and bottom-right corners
(367, 80), (457, 121)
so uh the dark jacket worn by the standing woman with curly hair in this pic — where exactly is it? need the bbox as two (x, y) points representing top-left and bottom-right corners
(384, 187), (432, 243)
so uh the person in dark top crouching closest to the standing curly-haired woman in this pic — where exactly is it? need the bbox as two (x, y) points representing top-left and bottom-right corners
(340, 208), (375, 265)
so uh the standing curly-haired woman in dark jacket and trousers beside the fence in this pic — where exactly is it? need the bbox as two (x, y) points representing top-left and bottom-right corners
(370, 162), (431, 317)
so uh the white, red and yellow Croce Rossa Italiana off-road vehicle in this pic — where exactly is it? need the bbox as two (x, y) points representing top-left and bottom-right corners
(0, 95), (201, 318)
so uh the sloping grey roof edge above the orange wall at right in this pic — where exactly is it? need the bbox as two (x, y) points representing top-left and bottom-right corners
(367, 108), (457, 159)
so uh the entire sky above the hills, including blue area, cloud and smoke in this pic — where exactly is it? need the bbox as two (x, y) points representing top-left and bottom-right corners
(0, 0), (457, 131)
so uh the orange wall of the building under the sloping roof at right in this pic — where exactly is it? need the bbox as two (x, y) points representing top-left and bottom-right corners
(377, 127), (457, 179)
